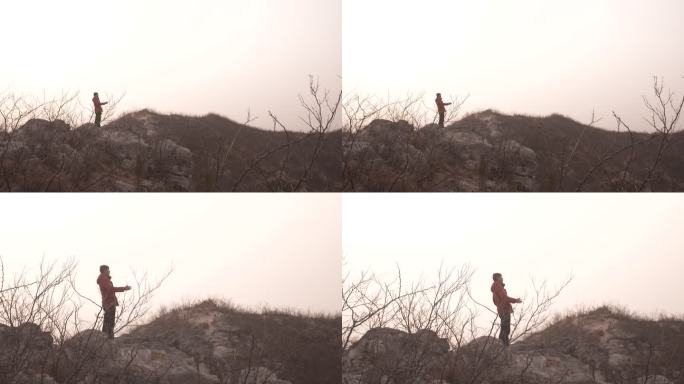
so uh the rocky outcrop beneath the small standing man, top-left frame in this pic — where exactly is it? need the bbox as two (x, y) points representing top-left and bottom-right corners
(0, 114), (193, 191)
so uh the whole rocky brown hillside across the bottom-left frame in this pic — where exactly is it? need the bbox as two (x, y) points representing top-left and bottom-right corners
(0, 300), (341, 384)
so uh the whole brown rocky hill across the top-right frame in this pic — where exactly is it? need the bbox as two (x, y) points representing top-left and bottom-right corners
(344, 110), (684, 191)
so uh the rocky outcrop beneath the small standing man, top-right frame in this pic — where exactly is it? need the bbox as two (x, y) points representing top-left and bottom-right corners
(345, 113), (539, 191)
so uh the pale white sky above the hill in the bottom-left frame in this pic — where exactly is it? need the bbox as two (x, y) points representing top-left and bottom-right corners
(0, 193), (342, 313)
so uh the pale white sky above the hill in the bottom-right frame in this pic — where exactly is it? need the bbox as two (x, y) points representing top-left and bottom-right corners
(342, 194), (684, 320)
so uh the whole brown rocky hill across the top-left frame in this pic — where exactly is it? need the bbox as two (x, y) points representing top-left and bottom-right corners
(0, 110), (342, 191)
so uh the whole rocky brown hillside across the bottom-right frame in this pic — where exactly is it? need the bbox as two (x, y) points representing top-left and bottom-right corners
(342, 307), (684, 384)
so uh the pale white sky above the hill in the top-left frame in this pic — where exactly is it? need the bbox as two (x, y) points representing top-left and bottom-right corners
(0, 0), (341, 128)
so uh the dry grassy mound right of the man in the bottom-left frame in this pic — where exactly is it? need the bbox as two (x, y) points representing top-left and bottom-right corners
(127, 299), (341, 384)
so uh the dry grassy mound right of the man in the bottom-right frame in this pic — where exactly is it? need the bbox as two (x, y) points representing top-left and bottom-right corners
(520, 304), (684, 383)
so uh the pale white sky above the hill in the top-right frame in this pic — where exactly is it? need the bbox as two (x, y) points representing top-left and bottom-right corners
(342, 0), (684, 129)
